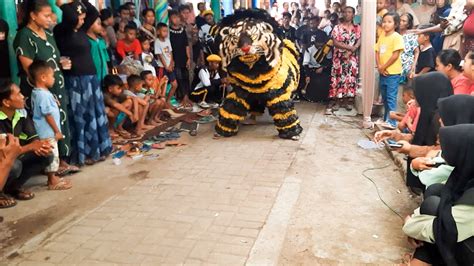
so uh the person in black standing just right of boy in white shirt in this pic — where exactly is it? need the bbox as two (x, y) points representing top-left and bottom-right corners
(168, 10), (192, 108)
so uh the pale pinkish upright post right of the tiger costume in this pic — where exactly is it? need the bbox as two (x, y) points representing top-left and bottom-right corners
(359, 0), (377, 128)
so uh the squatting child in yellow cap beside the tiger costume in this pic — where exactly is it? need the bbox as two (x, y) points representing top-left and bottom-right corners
(191, 54), (227, 108)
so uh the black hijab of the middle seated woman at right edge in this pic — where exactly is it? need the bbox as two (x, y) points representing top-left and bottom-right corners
(438, 94), (474, 126)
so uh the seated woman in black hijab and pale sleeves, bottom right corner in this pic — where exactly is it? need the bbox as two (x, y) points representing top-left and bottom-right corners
(403, 124), (474, 265)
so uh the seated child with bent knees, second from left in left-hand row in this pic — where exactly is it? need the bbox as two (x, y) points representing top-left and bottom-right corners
(124, 75), (157, 131)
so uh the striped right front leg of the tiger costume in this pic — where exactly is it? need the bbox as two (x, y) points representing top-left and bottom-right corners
(267, 88), (303, 139)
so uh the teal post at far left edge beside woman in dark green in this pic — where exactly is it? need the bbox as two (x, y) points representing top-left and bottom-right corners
(0, 1), (20, 84)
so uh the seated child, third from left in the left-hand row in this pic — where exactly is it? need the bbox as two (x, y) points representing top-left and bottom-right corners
(140, 70), (168, 123)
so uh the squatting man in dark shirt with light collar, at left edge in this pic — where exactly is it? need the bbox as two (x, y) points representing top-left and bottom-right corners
(0, 81), (53, 208)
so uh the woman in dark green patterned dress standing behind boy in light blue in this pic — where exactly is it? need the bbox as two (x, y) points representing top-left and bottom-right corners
(13, 0), (79, 175)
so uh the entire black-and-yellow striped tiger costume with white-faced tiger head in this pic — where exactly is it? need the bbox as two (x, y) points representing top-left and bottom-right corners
(215, 9), (303, 139)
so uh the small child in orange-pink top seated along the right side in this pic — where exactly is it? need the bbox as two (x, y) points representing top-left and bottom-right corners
(390, 85), (420, 133)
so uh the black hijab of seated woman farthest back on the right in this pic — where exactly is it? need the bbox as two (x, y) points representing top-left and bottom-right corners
(412, 72), (453, 146)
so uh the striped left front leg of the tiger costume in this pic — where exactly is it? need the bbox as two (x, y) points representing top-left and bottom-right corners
(215, 89), (250, 137)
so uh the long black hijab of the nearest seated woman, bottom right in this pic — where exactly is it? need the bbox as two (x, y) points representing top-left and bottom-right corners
(433, 124), (474, 265)
